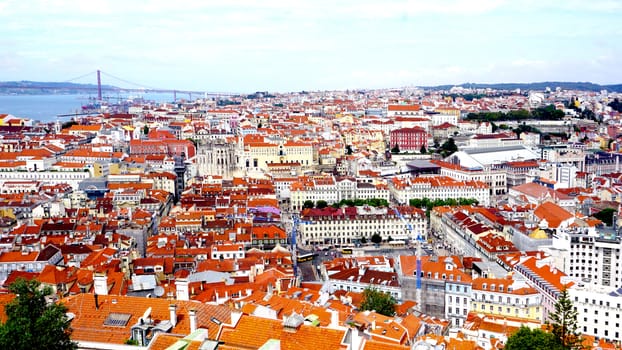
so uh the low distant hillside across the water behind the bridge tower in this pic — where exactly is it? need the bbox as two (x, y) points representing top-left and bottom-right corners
(0, 80), (119, 95)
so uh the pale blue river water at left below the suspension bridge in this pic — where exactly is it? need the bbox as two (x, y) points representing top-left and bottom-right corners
(0, 94), (173, 122)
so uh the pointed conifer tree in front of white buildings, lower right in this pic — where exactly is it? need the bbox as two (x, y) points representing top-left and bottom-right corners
(547, 287), (581, 350)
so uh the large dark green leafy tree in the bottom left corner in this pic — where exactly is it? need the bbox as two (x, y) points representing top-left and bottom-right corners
(0, 278), (77, 350)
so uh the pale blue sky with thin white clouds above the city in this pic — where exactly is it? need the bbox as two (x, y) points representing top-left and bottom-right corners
(0, 0), (622, 92)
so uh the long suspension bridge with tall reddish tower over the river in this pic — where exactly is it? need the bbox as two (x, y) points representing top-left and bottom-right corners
(6, 70), (240, 101)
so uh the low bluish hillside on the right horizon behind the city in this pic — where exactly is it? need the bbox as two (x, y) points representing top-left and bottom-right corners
(422, 81), (622, 92)
